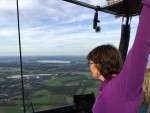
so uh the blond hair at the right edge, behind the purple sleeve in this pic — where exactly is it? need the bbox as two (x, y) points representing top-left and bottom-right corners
(142, 68), (150, 104)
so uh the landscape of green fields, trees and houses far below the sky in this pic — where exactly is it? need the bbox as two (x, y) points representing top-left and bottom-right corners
(0, 56), (99, 113)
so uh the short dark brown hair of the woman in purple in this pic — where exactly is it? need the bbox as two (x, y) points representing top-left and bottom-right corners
(87, 44), (123, 79)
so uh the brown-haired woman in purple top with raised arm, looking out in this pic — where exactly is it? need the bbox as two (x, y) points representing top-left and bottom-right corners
(87, 0), (150, 113)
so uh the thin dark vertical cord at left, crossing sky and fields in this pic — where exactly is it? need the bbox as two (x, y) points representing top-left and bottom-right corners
(16, 0), (26, 113)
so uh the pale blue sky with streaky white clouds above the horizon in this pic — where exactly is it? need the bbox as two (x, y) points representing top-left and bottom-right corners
(0, 0), (139, 56)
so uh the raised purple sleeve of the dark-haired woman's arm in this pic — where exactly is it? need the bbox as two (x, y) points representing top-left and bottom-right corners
(116, 0), (150, 96)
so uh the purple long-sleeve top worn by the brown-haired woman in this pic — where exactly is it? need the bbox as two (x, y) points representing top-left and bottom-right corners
(93, 0), (150, 113)
